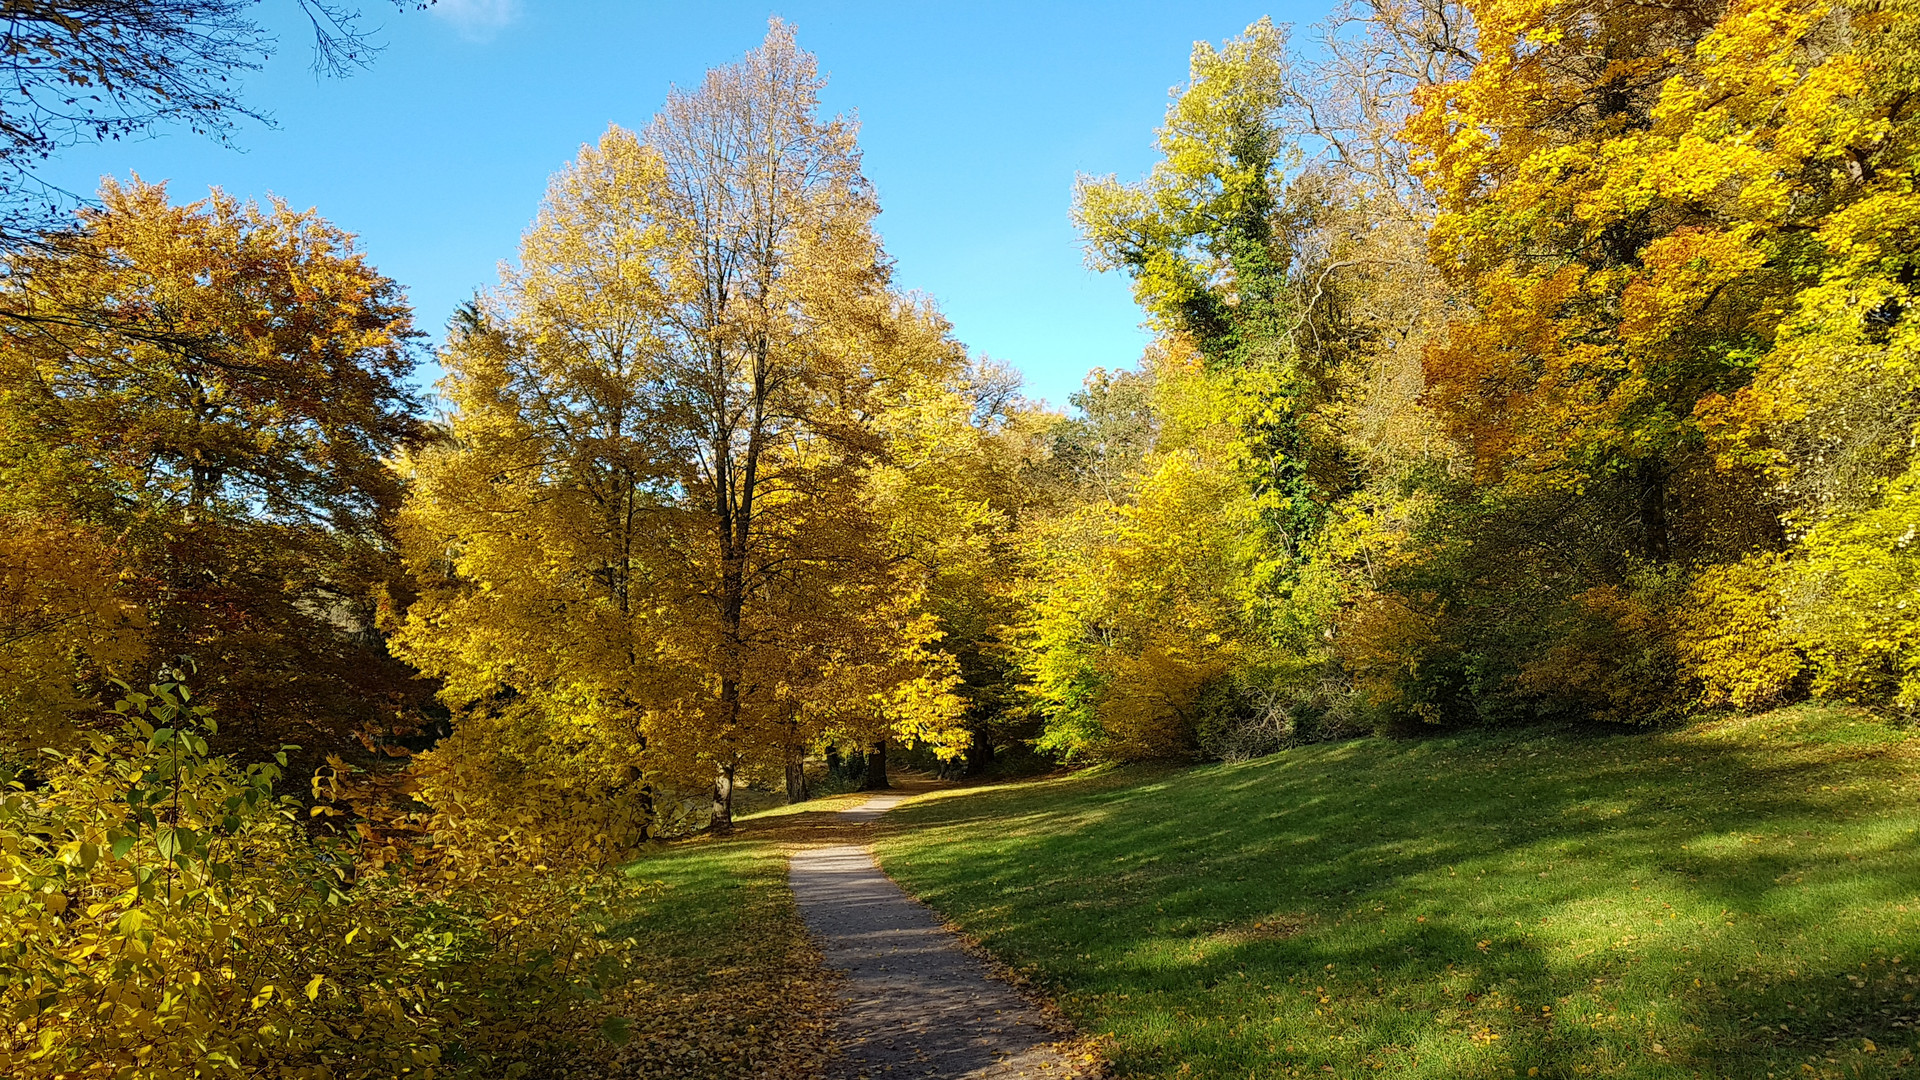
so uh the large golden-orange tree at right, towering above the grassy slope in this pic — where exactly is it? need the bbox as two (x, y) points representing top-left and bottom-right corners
(1407, 0), (1914, 719)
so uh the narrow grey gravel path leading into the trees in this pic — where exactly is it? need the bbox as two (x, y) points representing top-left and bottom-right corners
(789, 794), (1077, 1080)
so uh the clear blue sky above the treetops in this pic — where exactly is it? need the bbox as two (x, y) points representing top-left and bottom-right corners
(46, 0), (1325, 405)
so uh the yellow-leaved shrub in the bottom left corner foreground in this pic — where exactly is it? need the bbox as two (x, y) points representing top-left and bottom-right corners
(0, 686), (625, 1080)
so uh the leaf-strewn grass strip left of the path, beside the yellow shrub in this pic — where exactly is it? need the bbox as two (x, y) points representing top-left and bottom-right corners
(597, 838), (831, 1080)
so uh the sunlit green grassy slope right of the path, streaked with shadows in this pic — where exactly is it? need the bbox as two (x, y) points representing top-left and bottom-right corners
(879, 707), (1920, 1080)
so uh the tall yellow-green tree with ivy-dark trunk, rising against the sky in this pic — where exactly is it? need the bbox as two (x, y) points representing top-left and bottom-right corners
(1075, 4), (1448, 588)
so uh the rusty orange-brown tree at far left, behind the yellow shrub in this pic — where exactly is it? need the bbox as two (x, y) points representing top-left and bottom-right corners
(0, 181), (424, 746)
